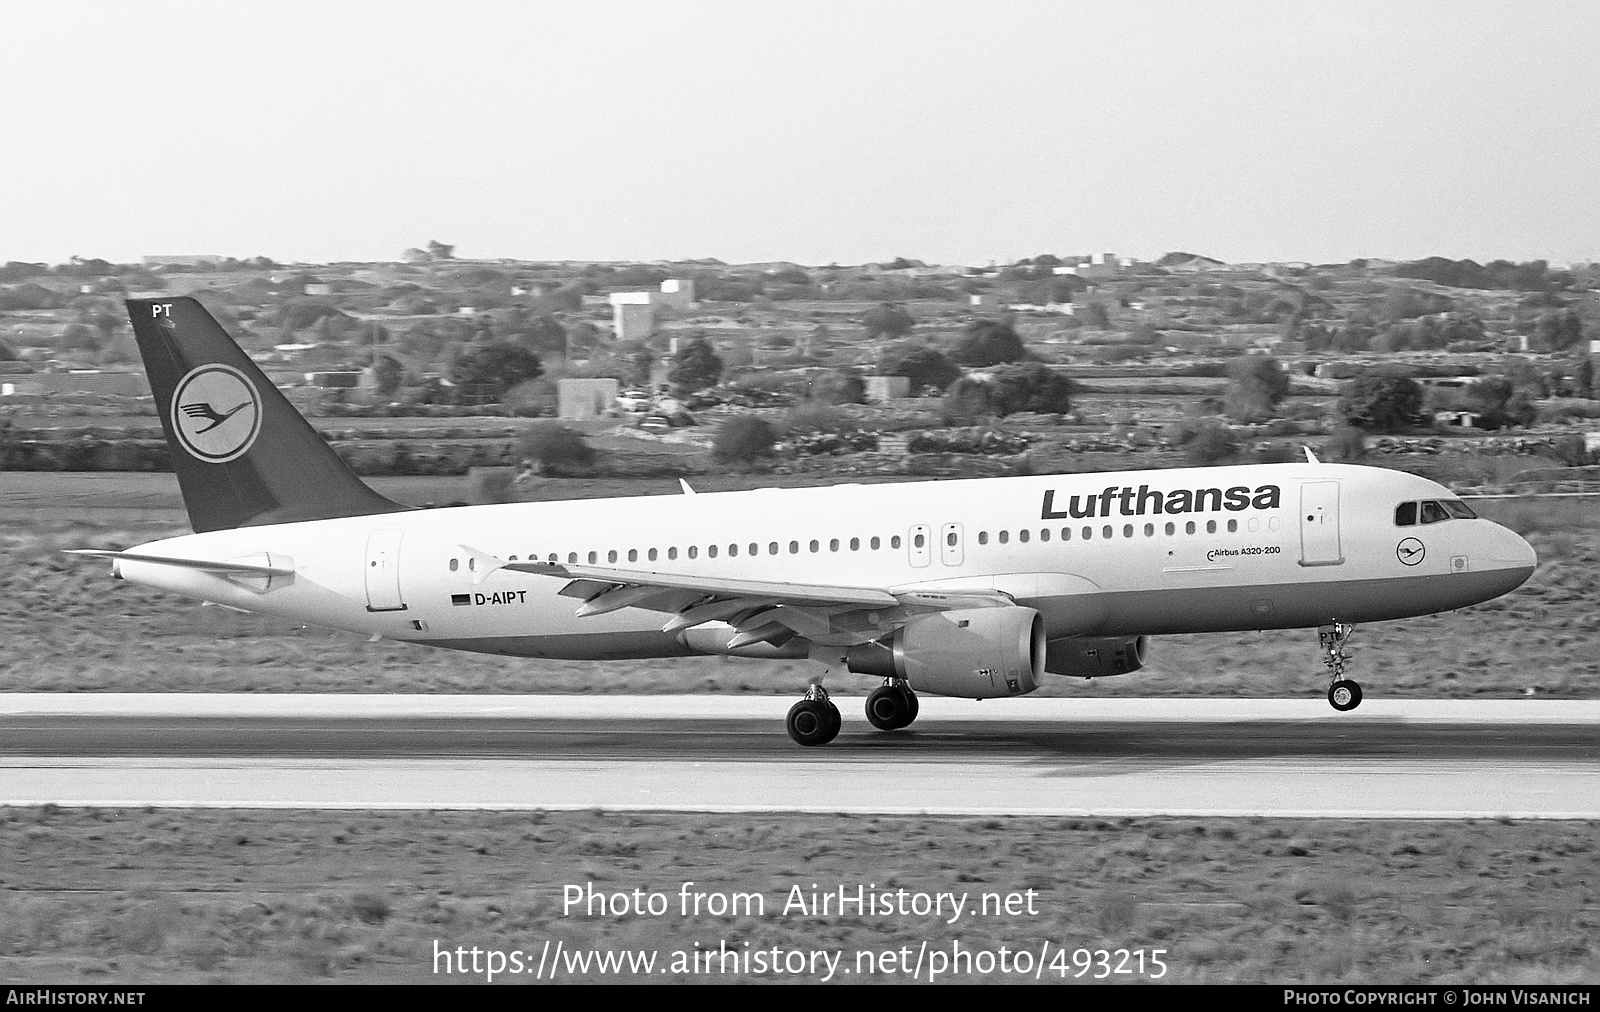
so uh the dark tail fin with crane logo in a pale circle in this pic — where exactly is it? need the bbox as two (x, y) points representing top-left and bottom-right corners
(128, 298), (408, 532)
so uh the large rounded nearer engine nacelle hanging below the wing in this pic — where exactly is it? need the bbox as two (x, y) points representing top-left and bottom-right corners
(845, 605), (1045, 700)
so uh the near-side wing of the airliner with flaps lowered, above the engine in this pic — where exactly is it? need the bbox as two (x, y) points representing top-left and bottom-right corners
(461, 544), (1014, 649)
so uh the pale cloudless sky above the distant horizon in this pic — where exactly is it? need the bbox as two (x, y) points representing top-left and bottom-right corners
(0, 0), (1600, 264)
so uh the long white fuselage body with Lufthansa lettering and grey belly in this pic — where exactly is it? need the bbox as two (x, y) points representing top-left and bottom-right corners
(118, 463), (1534, 669)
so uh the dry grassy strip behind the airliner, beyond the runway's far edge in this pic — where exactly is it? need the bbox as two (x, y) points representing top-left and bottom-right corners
(0, 485), (1600, 698)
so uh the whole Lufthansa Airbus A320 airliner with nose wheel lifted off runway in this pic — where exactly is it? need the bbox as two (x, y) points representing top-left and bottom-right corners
(72, 298), (1536, 745)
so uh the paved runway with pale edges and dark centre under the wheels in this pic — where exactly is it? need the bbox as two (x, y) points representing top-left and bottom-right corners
(0, 693), (1600, 818)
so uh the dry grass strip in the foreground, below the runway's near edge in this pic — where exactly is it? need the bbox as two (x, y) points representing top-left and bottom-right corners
(0, 809), (1600, 983)
